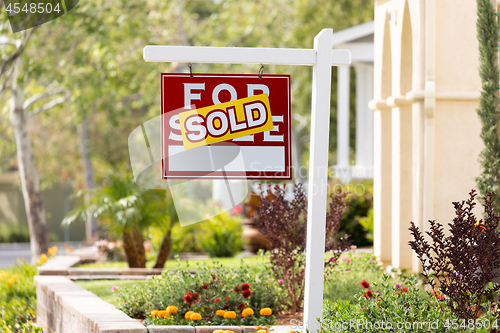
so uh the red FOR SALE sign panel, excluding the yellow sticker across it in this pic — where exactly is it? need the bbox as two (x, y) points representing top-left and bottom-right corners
(161, 74), (292, 180)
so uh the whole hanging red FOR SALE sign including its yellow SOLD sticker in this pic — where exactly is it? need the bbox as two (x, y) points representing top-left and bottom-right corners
(161, 73), (291, 180)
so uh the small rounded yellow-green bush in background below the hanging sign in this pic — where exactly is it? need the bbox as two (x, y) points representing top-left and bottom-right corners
(200, 212), (243, 258)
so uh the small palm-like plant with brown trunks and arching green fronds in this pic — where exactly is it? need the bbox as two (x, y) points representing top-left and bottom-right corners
(63, 173), (177, 268)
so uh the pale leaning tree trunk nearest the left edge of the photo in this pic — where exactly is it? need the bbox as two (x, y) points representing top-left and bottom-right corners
(10, 59), (50, 263)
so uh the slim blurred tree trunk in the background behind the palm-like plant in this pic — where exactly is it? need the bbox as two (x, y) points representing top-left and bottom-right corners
(78, 119), (98, 243)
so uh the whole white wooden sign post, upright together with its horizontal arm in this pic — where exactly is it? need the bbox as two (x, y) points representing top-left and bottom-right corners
(144, 29), (351, 332)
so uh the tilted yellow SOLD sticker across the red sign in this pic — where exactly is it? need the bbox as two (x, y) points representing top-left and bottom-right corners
(179, 94), (273, 150)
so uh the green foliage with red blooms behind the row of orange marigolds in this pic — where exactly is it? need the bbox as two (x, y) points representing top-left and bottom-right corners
(117, 254), (284, 325)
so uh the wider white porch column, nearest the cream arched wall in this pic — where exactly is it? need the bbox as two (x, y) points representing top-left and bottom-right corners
(354, 63), (373, 178)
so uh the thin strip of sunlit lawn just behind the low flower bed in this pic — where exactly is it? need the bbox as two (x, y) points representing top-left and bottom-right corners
(79, 256), (267, 269)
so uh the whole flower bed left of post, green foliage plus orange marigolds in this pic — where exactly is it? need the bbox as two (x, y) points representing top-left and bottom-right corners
(117, 260), (286, 326)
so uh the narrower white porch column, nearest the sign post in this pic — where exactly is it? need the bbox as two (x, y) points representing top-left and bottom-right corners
(337, 66), (351, 182)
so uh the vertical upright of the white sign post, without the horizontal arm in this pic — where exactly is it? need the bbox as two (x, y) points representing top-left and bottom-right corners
(304, 29), (333, 332)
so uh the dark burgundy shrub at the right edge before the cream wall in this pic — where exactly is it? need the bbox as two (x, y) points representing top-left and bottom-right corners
(410, 190), (500, 320)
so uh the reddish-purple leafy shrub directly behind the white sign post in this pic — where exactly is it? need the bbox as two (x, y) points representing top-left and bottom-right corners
(252, 184), (349, 312)
